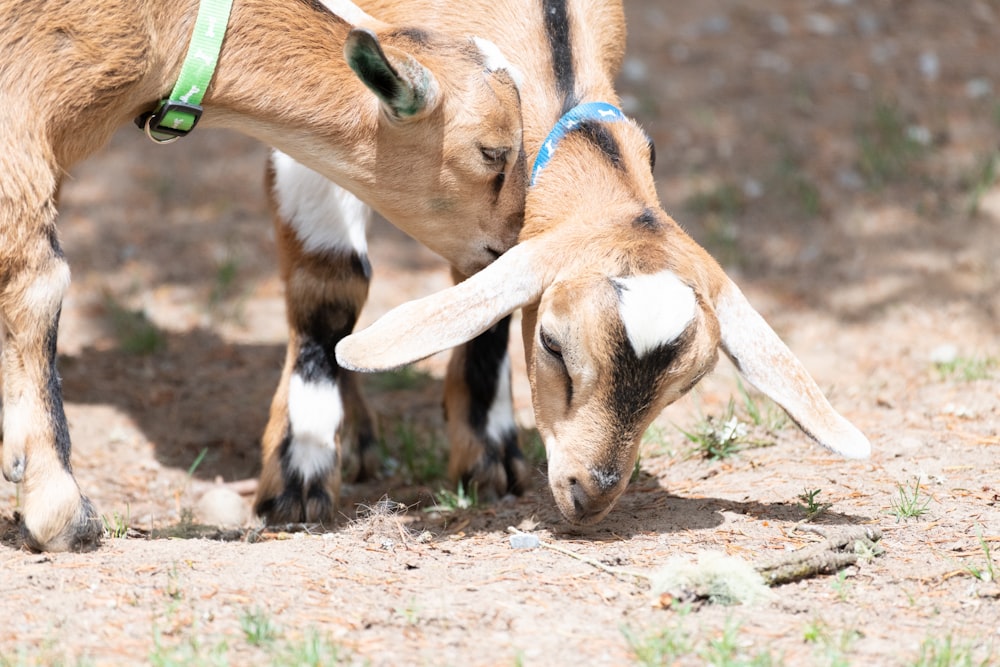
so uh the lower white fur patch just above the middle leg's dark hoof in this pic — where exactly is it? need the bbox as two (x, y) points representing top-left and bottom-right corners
(288, 374), (344, 481)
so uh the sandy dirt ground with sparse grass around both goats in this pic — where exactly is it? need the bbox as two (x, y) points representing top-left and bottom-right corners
(0, 0), (1000, 665)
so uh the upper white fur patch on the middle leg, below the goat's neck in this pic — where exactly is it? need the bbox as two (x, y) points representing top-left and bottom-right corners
(273, 151), (371, 257)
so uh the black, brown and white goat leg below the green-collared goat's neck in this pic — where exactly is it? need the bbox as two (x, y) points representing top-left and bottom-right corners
(254, 158), (378, 524)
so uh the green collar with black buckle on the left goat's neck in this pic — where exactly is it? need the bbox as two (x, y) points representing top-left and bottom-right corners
(135, 0), (233, 144)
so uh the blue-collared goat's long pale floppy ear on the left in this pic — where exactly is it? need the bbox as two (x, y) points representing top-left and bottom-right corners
(337, 241), (545, 372)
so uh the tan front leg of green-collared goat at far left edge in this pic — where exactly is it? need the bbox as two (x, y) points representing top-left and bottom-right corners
(0, 196), (103, 551)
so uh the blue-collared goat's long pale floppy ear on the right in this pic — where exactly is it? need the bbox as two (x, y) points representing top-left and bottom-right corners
(715, 280), (871, 459)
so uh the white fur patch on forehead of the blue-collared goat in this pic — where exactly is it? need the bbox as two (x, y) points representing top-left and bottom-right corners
(615, 271), (697, 357)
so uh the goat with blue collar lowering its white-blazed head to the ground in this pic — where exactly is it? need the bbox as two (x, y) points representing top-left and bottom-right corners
(258, 0), (870, 523)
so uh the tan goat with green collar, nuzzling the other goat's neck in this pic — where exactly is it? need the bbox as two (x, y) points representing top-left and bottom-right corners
(0, 0), (524, 550)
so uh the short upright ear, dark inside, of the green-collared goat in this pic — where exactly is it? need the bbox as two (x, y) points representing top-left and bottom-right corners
(344, 28), (438, 120)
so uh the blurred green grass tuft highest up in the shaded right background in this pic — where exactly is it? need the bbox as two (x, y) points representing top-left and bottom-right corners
(857, 101), (926, 189)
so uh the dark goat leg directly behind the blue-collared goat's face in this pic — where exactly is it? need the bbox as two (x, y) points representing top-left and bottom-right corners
(444, 302), (530, 499)
